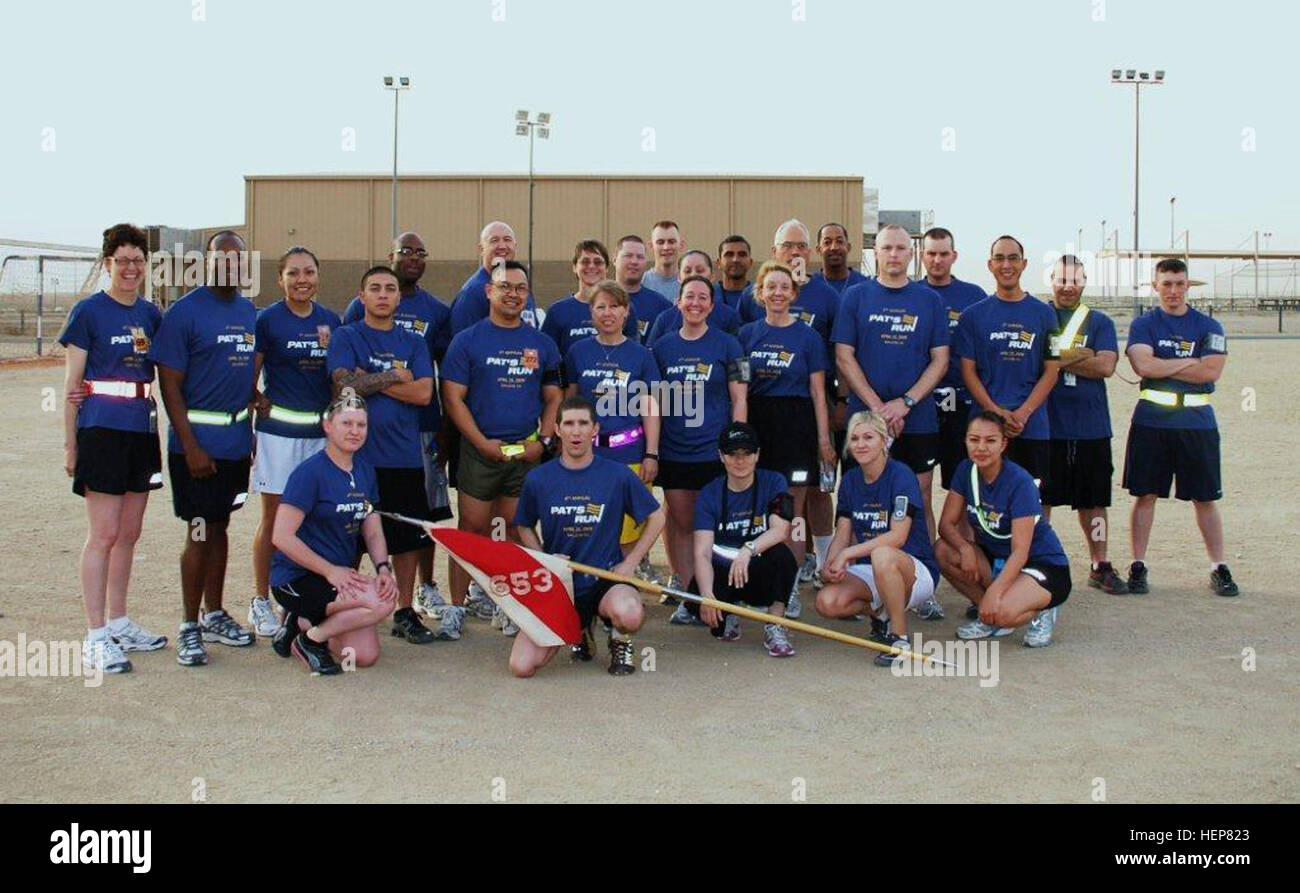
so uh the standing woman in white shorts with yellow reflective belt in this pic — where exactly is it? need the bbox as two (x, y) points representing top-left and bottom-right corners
(248, 246), (343, 637)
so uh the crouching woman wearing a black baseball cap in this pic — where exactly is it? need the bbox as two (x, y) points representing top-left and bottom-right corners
(688, 421), (800, 658)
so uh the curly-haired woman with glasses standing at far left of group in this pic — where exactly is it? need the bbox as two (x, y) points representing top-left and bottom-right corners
(59, 224), (166, 673)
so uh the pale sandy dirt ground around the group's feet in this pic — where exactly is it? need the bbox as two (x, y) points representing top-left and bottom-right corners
(0, 341), (1300, 802)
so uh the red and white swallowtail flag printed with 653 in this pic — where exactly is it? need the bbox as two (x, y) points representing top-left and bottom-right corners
(421, 525), (582, 647)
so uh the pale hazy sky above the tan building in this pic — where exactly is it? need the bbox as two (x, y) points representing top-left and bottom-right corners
(0, 0), (1300, 288)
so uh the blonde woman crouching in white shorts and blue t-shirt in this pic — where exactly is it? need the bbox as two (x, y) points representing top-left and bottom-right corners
(816, 412), (939, 667)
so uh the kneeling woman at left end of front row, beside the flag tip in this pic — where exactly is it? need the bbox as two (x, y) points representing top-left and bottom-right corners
(270, 389), (397, 676)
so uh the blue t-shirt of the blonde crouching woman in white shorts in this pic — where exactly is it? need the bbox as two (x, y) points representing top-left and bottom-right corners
(835, 459), (939, 584)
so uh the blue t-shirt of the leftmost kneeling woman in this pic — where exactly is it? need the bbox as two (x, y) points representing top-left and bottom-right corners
(270, 450), (380, 586)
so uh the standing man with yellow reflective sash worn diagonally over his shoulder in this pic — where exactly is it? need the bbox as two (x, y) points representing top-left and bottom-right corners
(1043, 255), (1128, 595)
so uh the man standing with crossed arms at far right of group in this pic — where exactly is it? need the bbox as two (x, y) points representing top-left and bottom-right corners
(1123, 257), (1239, 595)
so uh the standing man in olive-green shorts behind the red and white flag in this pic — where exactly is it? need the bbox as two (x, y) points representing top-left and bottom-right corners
(442, 260), (563, 621)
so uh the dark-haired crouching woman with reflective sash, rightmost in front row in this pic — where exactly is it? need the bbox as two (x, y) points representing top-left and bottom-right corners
(935, 411), (1070, 647)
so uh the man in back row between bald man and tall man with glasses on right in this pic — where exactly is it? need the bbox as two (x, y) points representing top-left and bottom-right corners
(920, 226), (988, 490)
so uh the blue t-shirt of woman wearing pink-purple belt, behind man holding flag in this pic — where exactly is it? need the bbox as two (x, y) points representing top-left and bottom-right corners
(564, 337), (659, 465)
